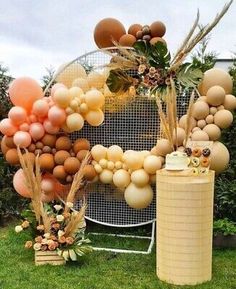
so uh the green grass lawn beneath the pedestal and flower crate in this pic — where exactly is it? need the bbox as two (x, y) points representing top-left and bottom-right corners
(0, 225), (236, 289)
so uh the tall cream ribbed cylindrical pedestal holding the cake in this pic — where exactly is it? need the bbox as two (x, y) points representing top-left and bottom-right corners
(157, 170), (214, 285)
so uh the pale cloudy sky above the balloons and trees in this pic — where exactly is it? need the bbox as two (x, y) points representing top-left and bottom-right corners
(0, 0), (236, 80)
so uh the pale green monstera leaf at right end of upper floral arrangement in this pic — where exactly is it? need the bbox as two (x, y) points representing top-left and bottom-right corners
(177, 63), (203, 88)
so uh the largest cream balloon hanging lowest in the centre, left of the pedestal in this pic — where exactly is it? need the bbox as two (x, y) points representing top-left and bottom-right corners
(125, 183), (153, 209)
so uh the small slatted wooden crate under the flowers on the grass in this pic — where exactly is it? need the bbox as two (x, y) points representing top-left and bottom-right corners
(35, 251), (66, 266)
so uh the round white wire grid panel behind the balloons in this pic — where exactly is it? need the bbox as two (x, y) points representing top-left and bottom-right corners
(60, 48), (188, 227)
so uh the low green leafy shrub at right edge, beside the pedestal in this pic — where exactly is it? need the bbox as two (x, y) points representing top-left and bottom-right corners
(213, 218), (236, 248)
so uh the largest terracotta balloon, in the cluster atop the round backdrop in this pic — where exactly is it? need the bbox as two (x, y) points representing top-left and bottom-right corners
(94, 18), (125, 48)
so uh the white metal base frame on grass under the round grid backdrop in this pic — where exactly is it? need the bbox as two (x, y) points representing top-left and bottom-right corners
(89, 220), (156, 255)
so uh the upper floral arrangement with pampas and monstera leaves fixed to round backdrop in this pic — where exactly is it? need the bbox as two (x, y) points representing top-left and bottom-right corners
(107, 0), (233, 150)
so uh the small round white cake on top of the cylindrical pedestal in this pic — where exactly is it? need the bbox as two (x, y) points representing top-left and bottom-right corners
(165, 151), (189, 171)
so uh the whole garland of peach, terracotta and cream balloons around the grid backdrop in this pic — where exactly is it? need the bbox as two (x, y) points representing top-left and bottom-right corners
(0, 3), (236, 209)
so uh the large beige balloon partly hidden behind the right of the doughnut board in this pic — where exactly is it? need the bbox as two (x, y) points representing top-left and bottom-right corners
(210, 141), (230, 174)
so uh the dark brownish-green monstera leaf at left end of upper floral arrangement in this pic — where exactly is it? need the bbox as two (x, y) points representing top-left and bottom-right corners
(106, 69), (133, 93)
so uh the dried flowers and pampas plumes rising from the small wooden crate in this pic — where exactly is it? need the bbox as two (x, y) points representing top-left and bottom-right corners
(15, 148), (92, 261)
